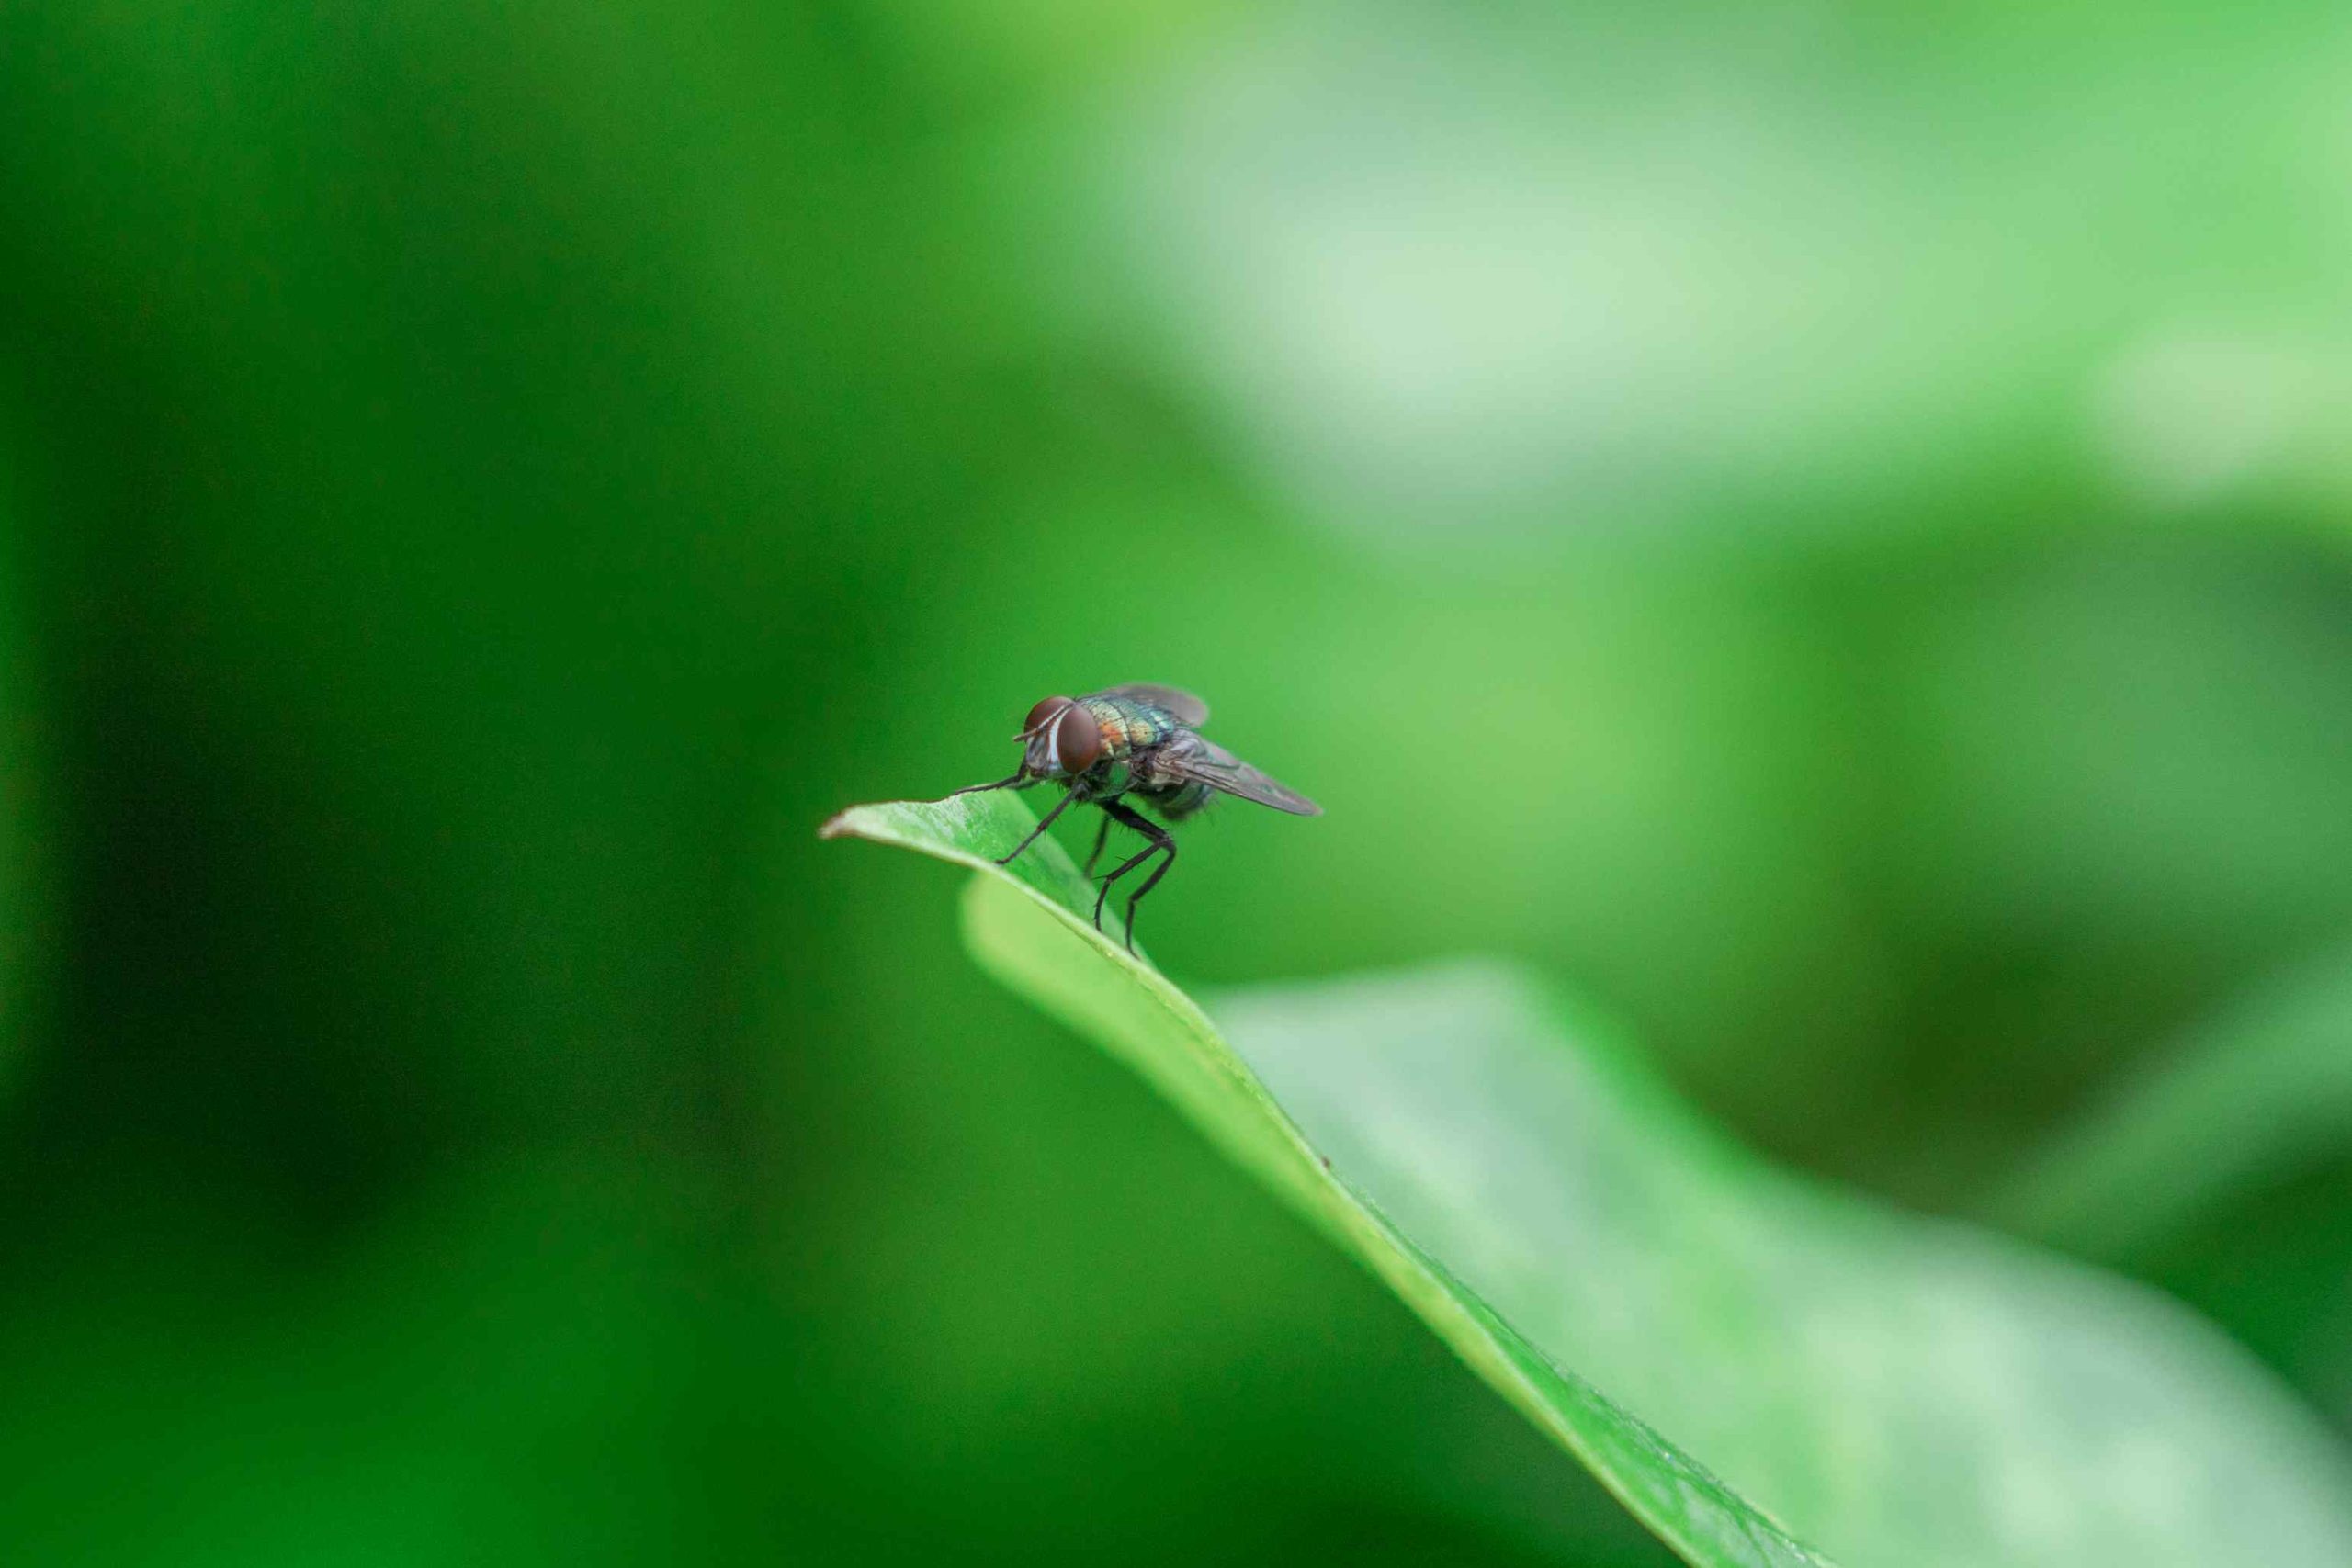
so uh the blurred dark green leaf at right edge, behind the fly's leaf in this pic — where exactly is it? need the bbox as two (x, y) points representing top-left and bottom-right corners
(1987, 952), (2352, 1262)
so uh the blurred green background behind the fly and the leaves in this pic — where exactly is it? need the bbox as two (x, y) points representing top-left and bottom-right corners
(0, 0), (2352, 1563)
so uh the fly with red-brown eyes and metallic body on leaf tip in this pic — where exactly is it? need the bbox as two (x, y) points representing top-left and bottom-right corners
(957, 684), (1322, 952)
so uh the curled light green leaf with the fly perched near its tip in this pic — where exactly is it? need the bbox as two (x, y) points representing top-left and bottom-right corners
(826, 795), (2352, 1568)
